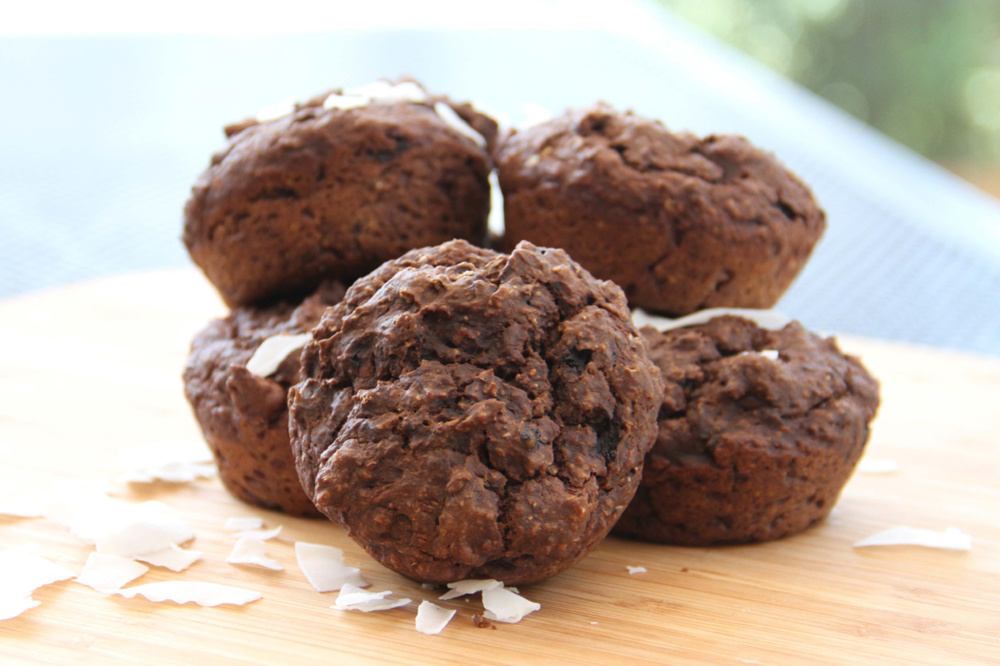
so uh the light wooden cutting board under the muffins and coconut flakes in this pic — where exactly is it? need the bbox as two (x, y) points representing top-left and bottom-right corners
(0, 270), (1000, 664)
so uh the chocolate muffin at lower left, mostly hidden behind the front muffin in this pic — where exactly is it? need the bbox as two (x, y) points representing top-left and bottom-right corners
(184, 283), (344, 516)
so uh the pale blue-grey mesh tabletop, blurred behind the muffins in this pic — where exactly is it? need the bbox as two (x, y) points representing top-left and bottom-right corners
(0, 6), (1000, 355)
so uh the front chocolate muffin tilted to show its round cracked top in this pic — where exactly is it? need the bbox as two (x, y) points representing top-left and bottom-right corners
(289, 241), (660, 584)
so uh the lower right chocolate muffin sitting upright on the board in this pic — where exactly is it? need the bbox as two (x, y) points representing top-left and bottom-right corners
(615, 316), (879, 546)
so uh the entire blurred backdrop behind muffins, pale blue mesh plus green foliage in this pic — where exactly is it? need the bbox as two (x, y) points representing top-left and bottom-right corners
(0, 0), (1000, 355)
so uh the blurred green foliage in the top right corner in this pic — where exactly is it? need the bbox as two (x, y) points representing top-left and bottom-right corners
(660, 0), (1000, 165)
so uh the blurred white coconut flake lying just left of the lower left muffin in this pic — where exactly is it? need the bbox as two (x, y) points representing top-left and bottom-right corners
(117, 441), (215, 483)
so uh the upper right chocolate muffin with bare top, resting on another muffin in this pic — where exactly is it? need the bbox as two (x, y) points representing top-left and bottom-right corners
(496, 104), (825, 316)
